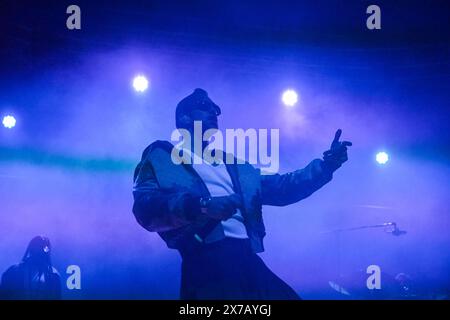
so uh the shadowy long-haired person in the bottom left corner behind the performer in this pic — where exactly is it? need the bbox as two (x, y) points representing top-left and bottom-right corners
(0, 236), (61, 300)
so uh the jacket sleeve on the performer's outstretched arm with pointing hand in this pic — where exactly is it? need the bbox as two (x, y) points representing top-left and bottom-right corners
(261, 159), (333, 206)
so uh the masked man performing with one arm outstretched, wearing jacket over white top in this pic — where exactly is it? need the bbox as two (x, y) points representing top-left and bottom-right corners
(133, 89), (351, 299)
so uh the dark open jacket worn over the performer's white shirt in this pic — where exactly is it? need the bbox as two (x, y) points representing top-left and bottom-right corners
(133, 141), (332, 252)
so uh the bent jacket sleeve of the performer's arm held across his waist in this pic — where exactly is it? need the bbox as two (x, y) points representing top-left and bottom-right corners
(133, 153), (200, 232)
